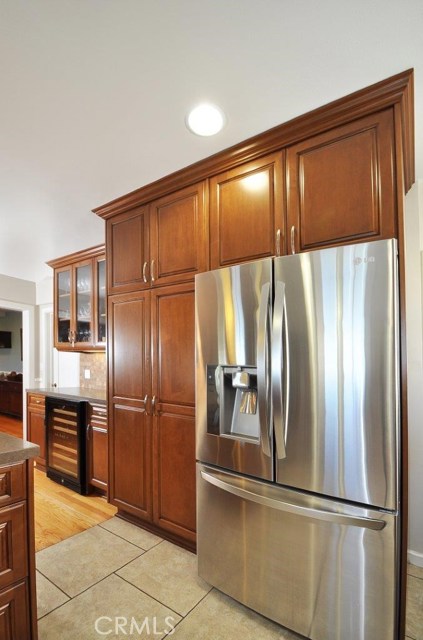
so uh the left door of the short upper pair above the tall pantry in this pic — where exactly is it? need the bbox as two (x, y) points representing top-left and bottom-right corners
(106, 207), (149, 293)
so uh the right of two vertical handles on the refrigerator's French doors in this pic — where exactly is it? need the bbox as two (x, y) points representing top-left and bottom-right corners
(272, 281), (289, 460)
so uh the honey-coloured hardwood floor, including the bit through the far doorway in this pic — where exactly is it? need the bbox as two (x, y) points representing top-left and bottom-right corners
(0, 414), (116, 551)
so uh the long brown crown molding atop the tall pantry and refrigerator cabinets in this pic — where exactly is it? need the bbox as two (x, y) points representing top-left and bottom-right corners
(93, 69), (415, 218)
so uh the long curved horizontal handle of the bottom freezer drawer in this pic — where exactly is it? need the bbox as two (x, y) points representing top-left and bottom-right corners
(201, 469), (386, 531)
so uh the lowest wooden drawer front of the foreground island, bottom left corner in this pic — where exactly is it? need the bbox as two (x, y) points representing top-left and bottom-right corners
(0, 580), (32, 640)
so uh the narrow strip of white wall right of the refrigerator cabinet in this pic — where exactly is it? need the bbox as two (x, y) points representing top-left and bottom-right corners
(405, 180), (423, 567)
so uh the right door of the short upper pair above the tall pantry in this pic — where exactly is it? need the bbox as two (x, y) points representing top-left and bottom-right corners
(150, 182), (208, 284)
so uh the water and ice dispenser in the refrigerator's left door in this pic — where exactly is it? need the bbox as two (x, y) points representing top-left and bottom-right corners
(207, 365), (260, 442)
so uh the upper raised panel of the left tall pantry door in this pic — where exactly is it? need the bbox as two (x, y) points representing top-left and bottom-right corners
(108, 291), (150, 405)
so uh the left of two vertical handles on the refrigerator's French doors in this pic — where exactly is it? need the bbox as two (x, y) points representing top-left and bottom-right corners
(257, 282), (271, 456)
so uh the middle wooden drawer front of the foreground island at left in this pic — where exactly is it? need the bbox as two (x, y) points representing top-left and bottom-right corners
(0, 502), (28, 589)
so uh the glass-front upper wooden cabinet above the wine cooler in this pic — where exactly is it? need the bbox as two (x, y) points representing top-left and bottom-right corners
(47, 245), (106, 351)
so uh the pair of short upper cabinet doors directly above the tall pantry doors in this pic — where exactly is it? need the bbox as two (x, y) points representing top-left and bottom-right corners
(106, 182), (209, 293)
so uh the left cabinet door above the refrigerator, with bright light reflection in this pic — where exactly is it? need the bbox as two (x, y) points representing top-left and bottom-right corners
(210, 152), (284, 269)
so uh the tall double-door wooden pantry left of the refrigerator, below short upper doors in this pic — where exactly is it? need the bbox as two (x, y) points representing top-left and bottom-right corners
(108, 282), (195, 548)
